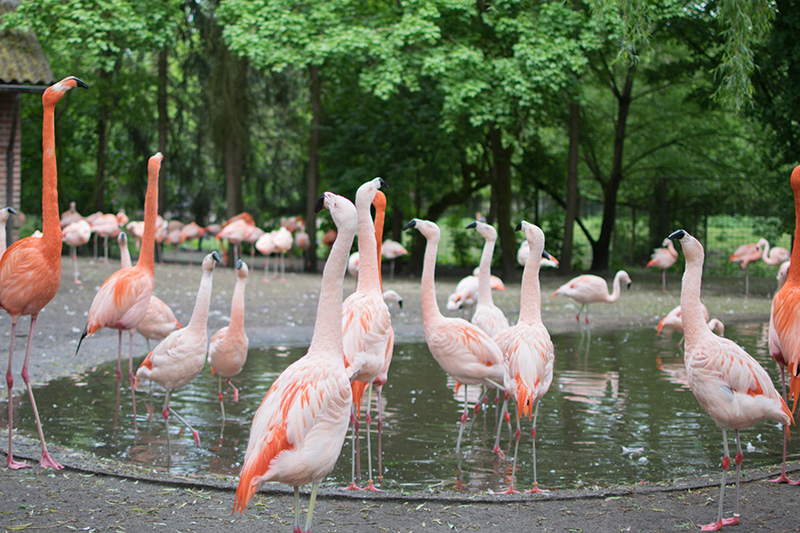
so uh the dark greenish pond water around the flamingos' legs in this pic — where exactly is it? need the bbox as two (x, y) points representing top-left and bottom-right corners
(10, 323), (782, 492)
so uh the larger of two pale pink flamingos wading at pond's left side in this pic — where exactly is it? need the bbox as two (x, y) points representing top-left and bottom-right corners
(134, 252), (220, 446)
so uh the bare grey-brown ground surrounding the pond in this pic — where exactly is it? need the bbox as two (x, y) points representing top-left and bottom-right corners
(0, 254), (800, 532)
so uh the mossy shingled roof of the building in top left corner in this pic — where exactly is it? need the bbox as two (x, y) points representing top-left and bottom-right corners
(0, 0), (55, 88)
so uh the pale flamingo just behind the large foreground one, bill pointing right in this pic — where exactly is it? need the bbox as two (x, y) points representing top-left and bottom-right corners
(342, 178), (394, 490)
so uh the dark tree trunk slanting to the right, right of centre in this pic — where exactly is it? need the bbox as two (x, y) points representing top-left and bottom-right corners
(592, 64), (636, 271)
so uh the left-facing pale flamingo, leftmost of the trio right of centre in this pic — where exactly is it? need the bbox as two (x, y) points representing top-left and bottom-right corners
(403, 218), (504, 462)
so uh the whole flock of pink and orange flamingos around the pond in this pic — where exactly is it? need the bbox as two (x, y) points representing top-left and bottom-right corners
(0, 77), (800, 531)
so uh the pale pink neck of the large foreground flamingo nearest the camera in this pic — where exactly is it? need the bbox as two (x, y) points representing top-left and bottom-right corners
(308, 211), (354, 354)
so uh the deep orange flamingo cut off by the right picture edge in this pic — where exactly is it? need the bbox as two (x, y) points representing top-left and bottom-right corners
(769, 166), (800, 485)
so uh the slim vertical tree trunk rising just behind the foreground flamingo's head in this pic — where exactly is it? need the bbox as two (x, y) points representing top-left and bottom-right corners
(305, 65), (322, 272)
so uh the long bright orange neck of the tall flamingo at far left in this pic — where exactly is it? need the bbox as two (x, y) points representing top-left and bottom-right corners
(42, 103), (61, 254)
